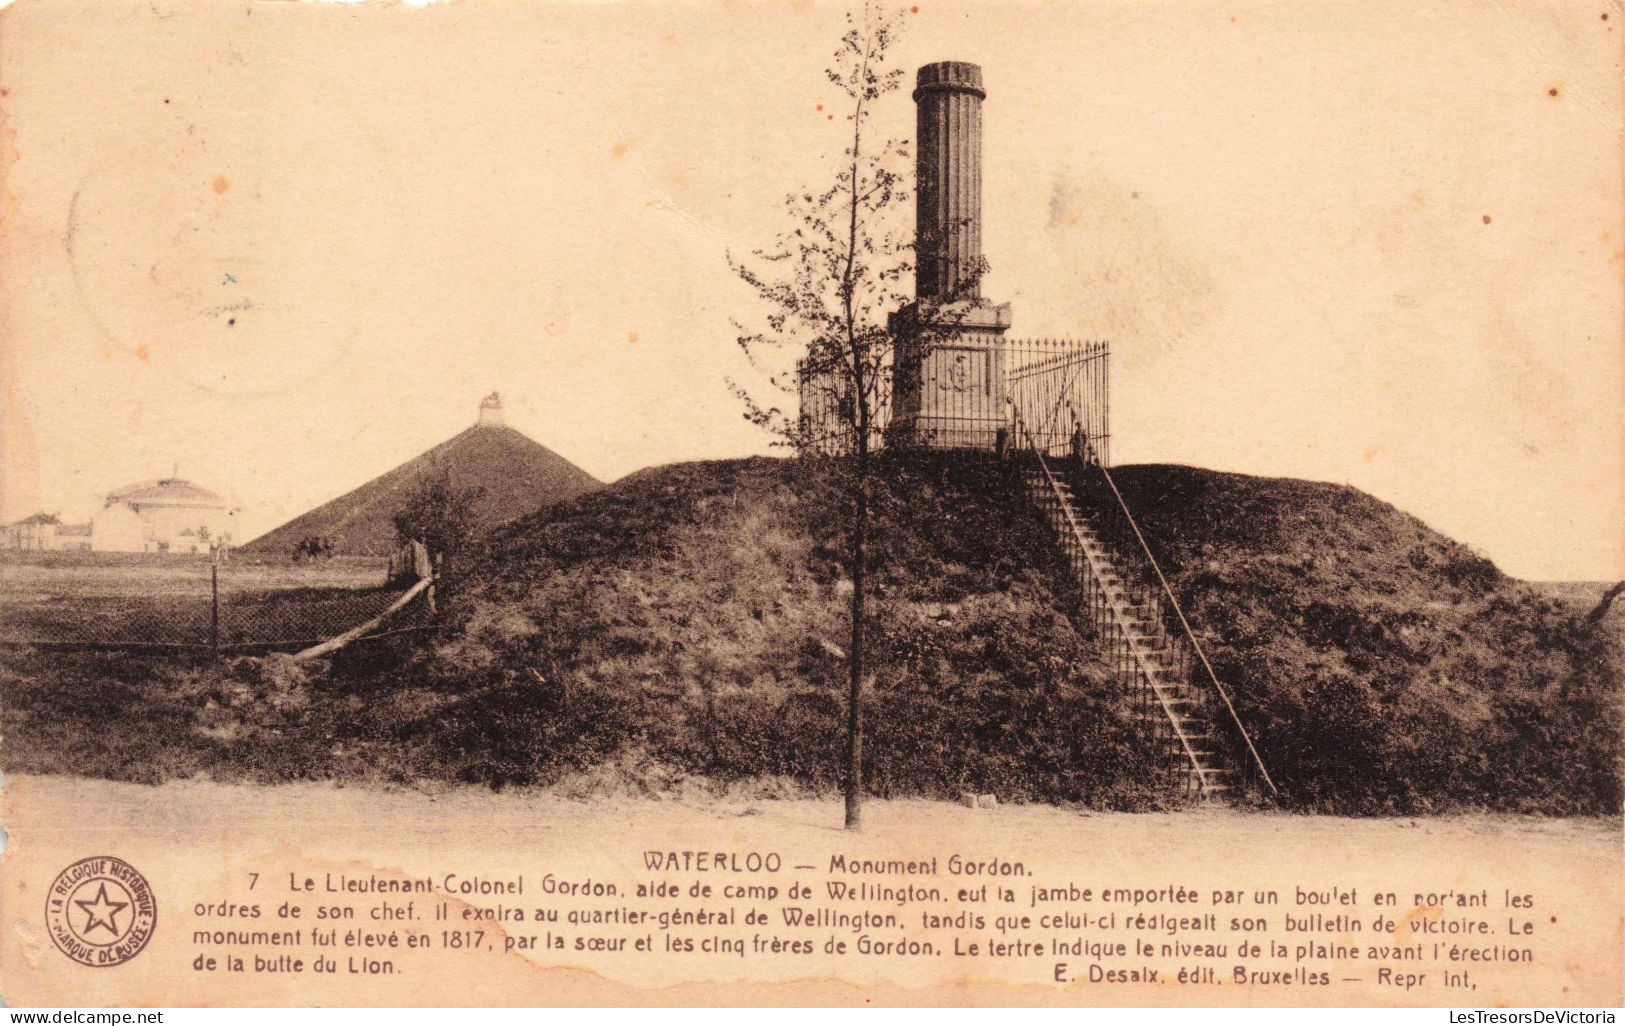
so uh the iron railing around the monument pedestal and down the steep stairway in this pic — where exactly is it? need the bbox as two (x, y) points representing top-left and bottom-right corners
(798, 333), (1276, 793)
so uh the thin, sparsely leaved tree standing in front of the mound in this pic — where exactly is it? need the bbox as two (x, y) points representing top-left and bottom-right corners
(730, 3), (913, 829)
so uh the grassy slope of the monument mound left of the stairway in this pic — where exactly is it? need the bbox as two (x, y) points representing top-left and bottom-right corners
(413, 459), (1160, 806)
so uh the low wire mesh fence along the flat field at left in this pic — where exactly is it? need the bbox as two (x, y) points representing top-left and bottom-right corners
(0, 551), (434, 655)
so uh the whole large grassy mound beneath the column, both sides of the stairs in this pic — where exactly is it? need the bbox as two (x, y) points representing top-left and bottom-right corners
(403, 459), (1625, 813)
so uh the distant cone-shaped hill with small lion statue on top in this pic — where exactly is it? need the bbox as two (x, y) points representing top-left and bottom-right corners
(242, 424), (600, 556)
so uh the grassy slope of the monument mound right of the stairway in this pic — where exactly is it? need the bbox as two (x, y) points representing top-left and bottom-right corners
(1115, 465), (1625, 813)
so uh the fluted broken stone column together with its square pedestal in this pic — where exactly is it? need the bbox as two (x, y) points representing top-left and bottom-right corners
(891, 60), (1011, 449)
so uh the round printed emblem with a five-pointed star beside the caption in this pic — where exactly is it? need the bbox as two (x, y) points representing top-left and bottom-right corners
(46, 855), (158, 966)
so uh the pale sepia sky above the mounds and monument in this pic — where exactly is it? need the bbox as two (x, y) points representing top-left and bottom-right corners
(0, 0), (1625, 579)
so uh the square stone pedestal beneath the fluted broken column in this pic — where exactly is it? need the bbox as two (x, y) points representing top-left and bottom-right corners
(891, 299), (1011, 449)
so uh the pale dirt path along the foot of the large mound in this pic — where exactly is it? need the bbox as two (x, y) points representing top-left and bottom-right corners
(5, 774), (1622, 859)
